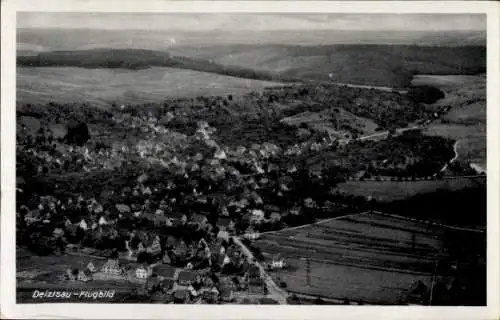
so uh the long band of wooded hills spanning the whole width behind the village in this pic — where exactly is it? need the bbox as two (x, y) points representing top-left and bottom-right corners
(17, 44), (486, 87)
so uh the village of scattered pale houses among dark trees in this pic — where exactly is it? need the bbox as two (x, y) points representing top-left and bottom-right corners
(17, 83), (480, 304)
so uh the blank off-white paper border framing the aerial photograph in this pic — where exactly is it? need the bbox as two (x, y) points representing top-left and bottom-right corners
(0, 0), (500, 319)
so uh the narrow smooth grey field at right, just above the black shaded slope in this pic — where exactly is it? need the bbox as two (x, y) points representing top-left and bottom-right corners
(336, 178), (485, 202)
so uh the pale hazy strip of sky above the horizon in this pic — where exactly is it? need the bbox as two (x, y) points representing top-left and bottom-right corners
(17, 12), (486, 31)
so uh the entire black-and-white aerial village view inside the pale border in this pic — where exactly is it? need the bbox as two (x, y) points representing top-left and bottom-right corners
(15, 12), (487, 306)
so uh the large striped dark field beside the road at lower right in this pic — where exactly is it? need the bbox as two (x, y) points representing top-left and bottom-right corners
(255, 214), (466, 304)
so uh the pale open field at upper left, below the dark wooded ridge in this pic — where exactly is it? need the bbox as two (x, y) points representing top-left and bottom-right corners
(17, 67), (286, 105)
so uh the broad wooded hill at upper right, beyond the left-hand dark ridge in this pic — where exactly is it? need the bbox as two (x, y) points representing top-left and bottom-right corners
(193, 44), (486, 87)
